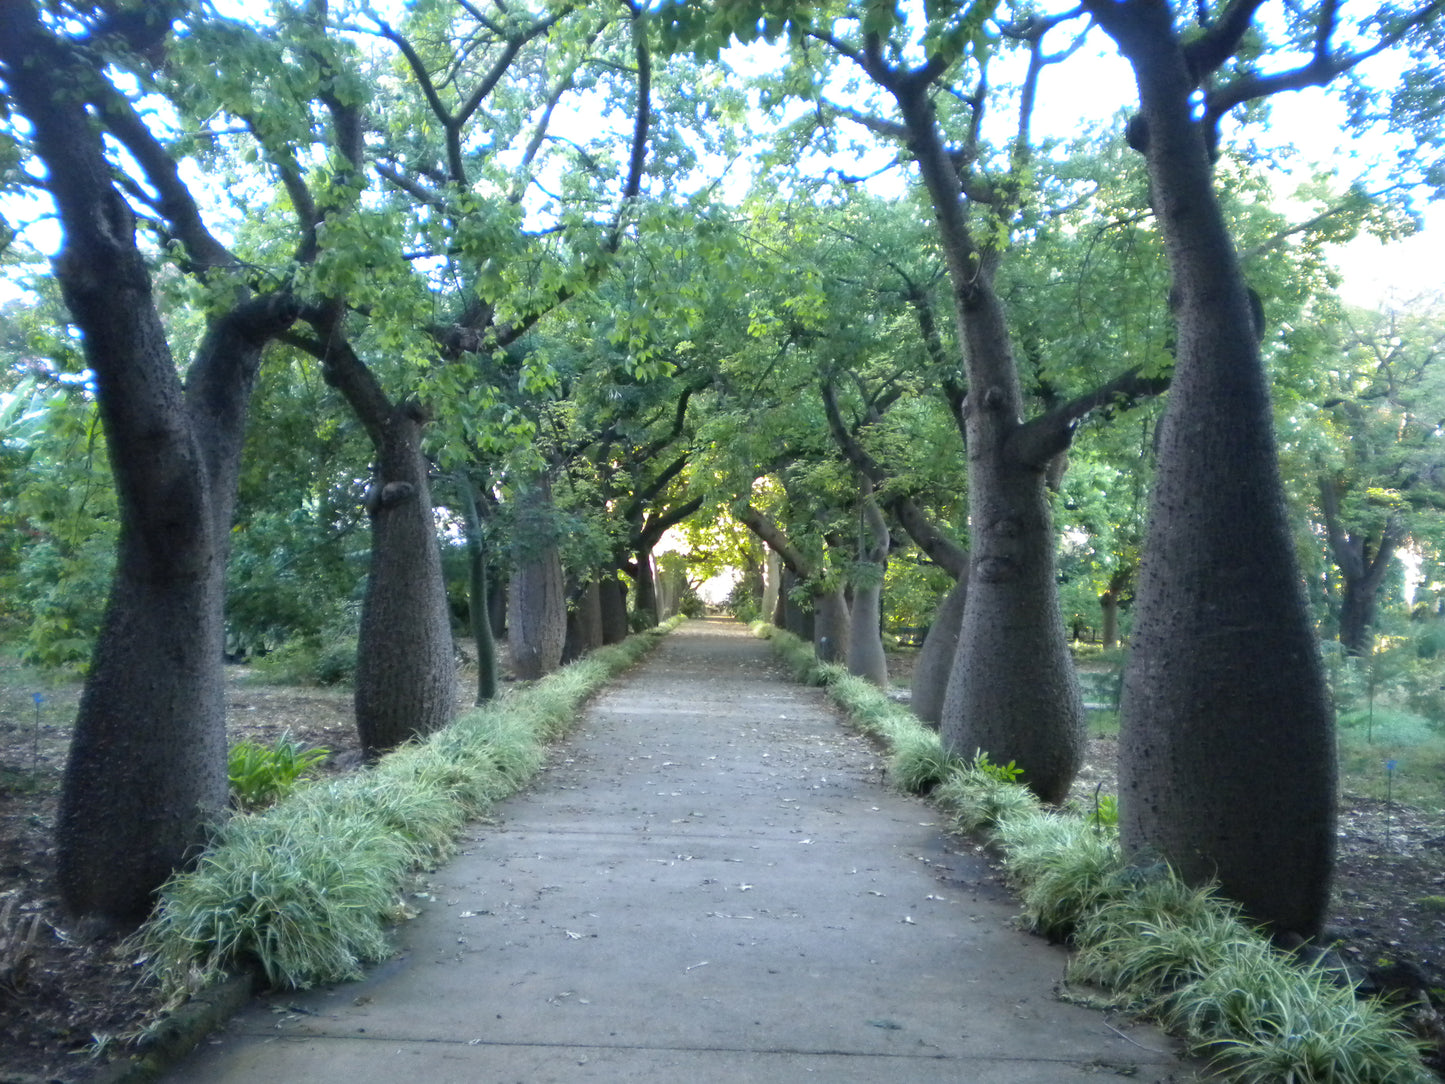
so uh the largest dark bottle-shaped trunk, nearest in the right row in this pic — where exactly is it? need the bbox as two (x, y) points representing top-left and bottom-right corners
(1092, 3), (1335, 937)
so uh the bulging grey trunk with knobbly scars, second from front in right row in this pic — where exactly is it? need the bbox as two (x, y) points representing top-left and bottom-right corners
(868, 72), (1084, 802)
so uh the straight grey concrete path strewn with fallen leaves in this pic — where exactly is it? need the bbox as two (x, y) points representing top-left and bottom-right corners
(168, 621), (1196, 1084)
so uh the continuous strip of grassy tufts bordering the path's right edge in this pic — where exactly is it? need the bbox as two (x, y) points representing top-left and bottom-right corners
(753, 623), (1436, 1084)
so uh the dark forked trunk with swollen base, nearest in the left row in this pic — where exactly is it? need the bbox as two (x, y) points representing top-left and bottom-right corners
(0, 14), (295, 926)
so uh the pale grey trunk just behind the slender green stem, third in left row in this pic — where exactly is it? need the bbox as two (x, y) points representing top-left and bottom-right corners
(507, 478), (566, 681)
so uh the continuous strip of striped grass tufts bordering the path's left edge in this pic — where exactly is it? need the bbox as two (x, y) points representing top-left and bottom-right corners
(136, 621), (676, 999)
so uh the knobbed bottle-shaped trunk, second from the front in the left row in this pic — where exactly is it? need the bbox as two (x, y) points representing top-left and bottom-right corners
(355, 403), (457, 757)
